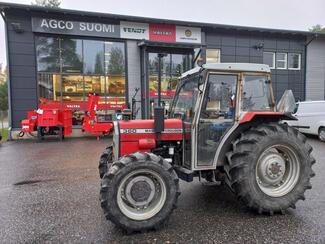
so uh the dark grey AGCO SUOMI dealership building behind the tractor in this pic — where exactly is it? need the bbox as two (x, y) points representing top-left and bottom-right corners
(0, 3), (325, 130)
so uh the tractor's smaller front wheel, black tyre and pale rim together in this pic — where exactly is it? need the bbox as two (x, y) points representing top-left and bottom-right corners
(100, 153), (180, 232)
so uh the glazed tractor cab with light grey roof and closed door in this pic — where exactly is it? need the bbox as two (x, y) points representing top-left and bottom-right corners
(169, 63), (275, 170)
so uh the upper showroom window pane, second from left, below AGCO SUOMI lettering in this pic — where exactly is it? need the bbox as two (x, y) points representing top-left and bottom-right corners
(61, 38), (83, 73)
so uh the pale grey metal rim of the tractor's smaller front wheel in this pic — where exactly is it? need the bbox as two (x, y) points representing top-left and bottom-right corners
(117, 169), (166, 220)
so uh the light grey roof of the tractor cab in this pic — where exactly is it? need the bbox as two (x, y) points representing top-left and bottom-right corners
(181, 63), (271, 78)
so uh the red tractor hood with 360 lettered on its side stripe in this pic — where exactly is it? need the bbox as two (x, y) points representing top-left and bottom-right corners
(114, 119), (183, 156)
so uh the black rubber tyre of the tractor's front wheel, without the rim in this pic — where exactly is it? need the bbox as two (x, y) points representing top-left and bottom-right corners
(100, 153), (180, 233)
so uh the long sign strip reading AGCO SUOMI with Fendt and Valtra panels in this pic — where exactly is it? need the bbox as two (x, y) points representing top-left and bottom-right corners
(32, 17), (201, 44)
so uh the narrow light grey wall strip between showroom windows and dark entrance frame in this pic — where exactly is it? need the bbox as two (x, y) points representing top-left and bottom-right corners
(126, 41), (141, 118)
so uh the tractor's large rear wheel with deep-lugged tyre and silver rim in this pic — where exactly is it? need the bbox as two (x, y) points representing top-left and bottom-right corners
(227, 123), (315, 215)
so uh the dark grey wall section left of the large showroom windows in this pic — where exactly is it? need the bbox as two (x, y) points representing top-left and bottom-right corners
(5, 10), (37, 128)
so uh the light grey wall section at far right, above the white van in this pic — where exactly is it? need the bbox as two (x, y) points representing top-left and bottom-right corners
(306, 38), (325, 100)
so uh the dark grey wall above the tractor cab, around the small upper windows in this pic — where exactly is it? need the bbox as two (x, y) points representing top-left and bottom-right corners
(206, 29), (305, 100)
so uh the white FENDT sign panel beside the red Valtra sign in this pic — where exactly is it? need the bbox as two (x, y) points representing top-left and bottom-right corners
(120, 21), (149, 40)
